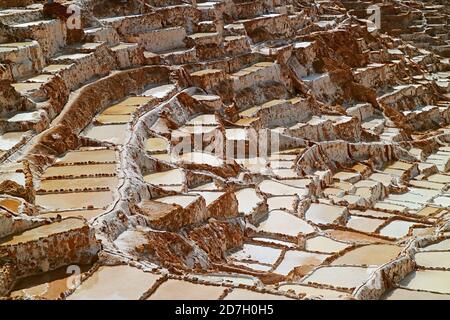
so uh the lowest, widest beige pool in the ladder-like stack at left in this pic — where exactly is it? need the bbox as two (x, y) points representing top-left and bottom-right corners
(36, 191), (114, 211)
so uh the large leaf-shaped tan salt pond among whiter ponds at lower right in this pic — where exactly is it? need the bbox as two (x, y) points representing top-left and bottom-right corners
(331, 244), (402, 266)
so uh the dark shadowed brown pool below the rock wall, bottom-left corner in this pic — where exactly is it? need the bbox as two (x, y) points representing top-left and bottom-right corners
(9, 266), (90, 300)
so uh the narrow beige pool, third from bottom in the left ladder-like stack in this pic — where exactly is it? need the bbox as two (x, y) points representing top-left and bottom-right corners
(42, 163), (116, 178)
